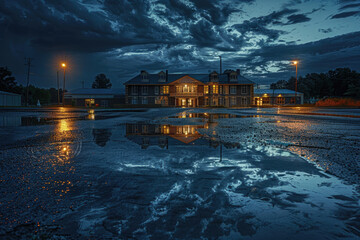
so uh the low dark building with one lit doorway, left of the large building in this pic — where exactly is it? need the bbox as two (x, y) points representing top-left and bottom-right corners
(64, 88), (124, 107)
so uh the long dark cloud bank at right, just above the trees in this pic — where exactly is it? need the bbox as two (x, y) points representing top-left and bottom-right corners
(233, 32), (360, 82)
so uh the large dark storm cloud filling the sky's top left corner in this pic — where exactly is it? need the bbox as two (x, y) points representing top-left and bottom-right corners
(0, 0), (175, 52)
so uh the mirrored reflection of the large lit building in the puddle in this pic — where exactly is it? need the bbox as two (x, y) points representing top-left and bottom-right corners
(126, 123), (239, 149)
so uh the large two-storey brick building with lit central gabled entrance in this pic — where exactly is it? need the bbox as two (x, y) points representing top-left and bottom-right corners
(124, 70), (254, 107)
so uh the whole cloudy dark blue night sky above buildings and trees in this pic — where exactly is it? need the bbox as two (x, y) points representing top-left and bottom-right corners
(0, 0), (360, 89)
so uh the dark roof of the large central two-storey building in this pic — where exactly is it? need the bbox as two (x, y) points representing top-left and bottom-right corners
(124, 73), (255, 85)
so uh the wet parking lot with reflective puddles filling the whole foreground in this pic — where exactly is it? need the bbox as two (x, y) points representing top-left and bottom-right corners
(0, 108), (360, 239)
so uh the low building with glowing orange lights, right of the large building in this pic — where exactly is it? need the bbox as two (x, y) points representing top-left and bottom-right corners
(254, 89), (304, 106)
